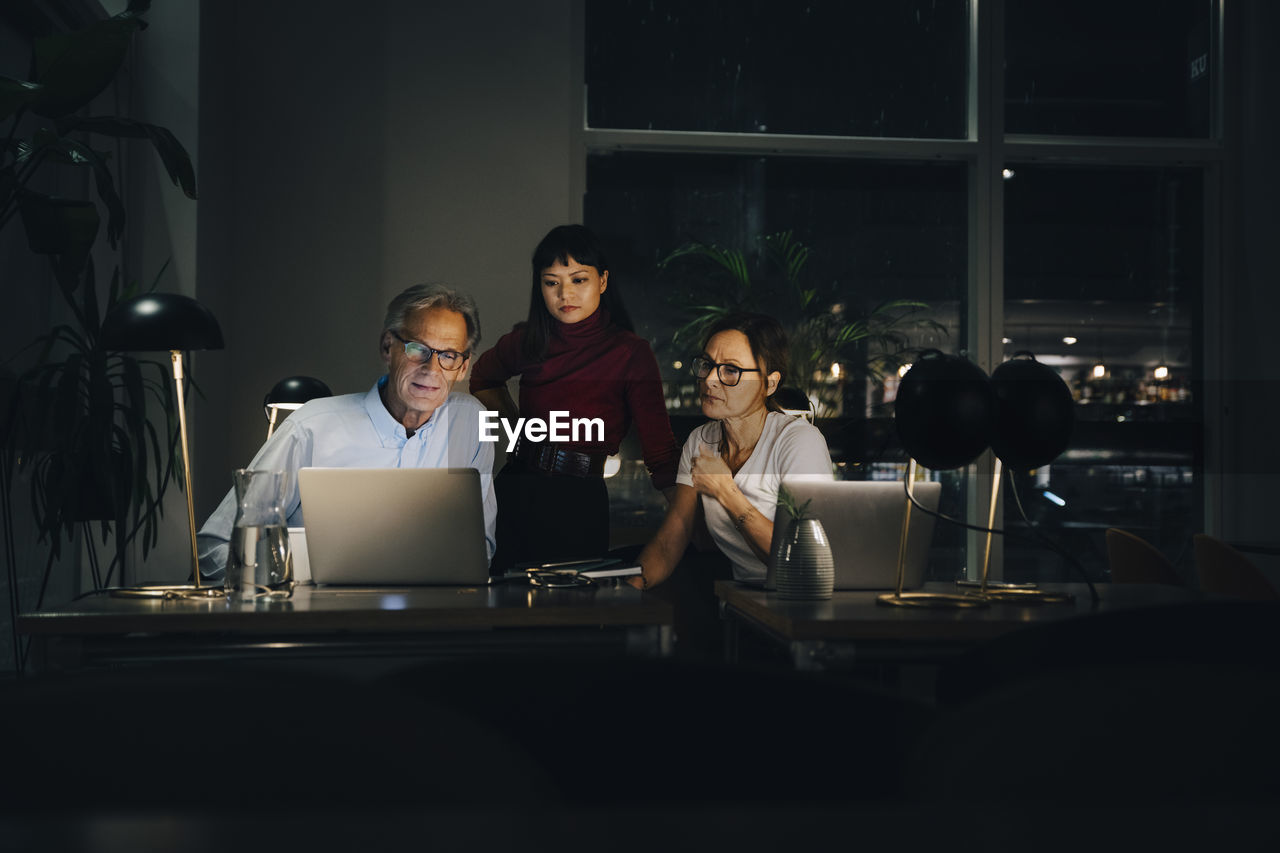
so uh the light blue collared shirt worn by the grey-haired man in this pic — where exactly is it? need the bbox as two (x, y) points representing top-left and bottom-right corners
(197, 377), (498, 580)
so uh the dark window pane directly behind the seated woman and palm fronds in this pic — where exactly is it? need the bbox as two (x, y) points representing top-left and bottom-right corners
(586, 152), (968, 579)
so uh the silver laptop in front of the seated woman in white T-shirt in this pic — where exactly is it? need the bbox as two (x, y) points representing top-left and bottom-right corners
(764, 480), (942, 589)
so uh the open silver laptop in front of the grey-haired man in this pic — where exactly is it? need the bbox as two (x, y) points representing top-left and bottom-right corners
(298, 467), (489, 587)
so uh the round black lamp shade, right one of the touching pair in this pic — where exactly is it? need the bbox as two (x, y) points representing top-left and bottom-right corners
(991, 353), (1075, 467)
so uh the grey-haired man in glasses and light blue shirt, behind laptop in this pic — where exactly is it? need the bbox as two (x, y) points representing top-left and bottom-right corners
(197, 284), (498, 580)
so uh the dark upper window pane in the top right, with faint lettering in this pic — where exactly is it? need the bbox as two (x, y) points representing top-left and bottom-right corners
(1005, 0), (1216, 137)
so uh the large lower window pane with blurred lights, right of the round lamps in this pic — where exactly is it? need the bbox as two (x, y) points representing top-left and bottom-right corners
(1005, 164), (1204, 580)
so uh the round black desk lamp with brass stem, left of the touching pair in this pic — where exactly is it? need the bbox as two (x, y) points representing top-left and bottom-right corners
(877, 350), (996, 607)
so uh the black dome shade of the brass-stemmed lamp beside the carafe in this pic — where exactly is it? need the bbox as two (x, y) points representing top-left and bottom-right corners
(100, 293), (223, 351)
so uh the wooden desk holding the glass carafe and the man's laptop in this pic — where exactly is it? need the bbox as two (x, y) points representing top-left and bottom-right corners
(18, 581), (672, 670)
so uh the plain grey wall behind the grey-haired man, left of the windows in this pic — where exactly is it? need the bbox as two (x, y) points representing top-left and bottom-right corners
(193, 0), (577, 540)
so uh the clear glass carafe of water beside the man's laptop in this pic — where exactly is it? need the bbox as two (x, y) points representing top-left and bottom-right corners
(223, 467), (293, 601)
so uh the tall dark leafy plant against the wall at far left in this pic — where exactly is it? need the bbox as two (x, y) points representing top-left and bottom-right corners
(0, 0), (196, 625)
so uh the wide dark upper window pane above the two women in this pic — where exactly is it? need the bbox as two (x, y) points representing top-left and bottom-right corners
(586, 0), (969, 138)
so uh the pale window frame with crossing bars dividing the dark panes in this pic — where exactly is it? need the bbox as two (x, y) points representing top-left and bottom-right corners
(570, 0), (1236, 580)
